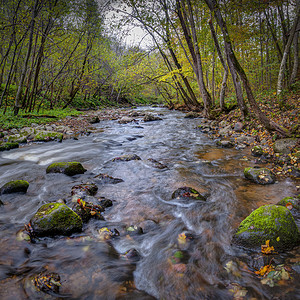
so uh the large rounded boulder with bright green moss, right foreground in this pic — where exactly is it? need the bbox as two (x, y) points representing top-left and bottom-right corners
(233, 205), (300, 251)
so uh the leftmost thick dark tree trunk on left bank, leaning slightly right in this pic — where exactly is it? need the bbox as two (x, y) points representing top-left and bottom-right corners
(14, 0), (39, 116)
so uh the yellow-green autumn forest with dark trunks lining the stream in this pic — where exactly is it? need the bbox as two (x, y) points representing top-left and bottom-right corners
(0, 0), (300, 133)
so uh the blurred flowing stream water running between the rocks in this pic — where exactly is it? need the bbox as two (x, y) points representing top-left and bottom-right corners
(0, 108), (300, 299)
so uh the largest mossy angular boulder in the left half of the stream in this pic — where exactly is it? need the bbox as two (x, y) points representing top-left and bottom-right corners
(30, 203), (82, 236)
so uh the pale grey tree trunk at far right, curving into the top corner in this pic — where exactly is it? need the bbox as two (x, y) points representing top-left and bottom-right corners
(277, 0), (300, 97)
